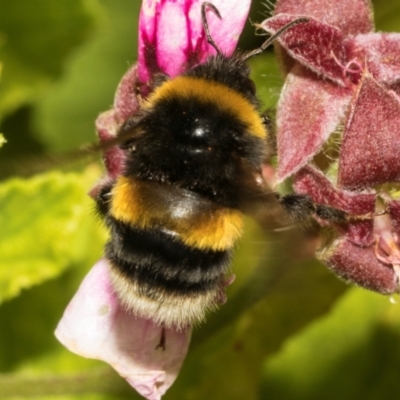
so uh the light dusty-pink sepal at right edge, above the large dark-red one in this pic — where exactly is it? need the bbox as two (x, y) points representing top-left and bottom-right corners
(346, 33), (400, 85)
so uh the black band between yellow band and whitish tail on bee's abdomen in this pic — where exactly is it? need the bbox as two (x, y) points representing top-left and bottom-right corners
(106, 216), (231, 295)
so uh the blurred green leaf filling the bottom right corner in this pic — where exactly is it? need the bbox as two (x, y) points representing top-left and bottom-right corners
(261, 288), (400, 400)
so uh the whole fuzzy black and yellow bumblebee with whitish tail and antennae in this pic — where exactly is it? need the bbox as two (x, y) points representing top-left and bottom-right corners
(96, 3), (310, 329)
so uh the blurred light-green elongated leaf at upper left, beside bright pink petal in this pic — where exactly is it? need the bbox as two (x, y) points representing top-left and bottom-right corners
(35, 0), (140, 151)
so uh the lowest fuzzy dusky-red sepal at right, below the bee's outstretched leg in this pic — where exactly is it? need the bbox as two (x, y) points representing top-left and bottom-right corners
(318, 237), (398, 294)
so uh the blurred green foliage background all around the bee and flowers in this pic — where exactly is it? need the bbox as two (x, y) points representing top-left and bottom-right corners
(0, 0), (400, 400)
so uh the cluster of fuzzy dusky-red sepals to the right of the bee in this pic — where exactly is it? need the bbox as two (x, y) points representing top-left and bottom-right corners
(262, 0), (400, 293)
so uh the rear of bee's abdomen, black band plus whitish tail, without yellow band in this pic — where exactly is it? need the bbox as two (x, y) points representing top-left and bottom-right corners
(106, 220), (231, 329)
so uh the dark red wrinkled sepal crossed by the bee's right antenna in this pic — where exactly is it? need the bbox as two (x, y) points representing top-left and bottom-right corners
(260, 14), (347, 86)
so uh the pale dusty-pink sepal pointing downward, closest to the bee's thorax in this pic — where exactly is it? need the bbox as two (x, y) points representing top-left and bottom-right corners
(277, 65), (350, 180)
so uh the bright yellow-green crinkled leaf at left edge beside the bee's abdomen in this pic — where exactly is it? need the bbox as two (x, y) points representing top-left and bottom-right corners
(0, 168), (106, 302)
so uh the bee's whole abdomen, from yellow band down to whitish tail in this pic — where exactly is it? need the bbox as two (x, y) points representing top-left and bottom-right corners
(99, 176), (242, 328)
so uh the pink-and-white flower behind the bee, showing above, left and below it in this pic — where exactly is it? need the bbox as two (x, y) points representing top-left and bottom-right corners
(56, 0), (250, 400)
